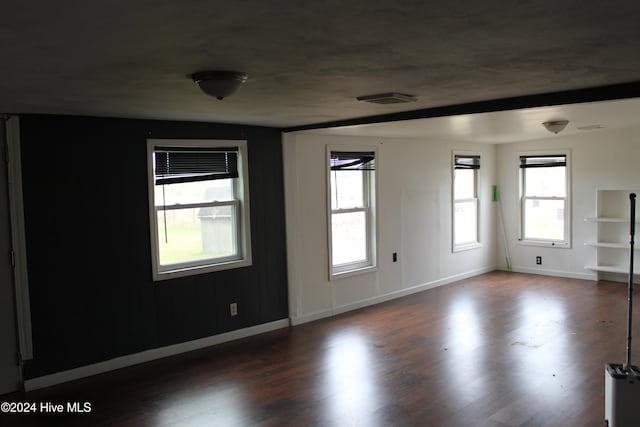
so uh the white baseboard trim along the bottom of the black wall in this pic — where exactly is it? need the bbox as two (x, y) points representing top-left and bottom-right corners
(24, 319), (290, 391)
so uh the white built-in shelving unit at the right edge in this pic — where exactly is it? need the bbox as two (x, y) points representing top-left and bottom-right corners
(585, 189), (640, 280)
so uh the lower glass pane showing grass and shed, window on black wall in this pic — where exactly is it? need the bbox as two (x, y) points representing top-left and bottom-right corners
(157, 206), (237, 265)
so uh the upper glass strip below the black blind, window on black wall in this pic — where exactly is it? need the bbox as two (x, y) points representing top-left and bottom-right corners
(155, 178), (234, 206)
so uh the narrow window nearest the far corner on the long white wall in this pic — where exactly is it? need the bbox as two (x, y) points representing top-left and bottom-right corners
(453, 153), (480, 252)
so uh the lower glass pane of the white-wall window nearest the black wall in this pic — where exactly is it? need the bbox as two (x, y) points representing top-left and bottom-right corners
(331, 212), (367, 265)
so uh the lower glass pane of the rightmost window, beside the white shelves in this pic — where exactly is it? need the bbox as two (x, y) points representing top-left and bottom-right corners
(524, 200), (565, 241)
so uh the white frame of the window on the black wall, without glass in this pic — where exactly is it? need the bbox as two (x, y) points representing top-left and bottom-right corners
(147, 139), (252, 281)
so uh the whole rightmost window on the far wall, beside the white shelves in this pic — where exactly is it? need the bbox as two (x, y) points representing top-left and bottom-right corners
(520, 153), (570, 247)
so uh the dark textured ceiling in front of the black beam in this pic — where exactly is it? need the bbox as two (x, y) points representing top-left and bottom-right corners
(0, 0), (640, 128)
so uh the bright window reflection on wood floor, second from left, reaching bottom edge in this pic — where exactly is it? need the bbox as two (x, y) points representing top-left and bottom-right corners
(323, 330), (380, 425)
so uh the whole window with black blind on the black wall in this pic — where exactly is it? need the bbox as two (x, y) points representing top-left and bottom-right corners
(147, 140), (251, 280)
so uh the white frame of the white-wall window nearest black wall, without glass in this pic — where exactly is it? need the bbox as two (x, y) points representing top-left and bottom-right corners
(325, 145), (380, 280)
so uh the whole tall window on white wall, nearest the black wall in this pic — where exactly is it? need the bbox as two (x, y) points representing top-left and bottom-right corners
(328, 149), (376, 277)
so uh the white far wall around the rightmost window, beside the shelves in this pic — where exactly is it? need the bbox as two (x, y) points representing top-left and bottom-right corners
(496, 128), (640, 279)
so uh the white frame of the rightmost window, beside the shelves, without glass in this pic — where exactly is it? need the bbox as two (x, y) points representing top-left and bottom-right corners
(516, 149), (572, 249)
